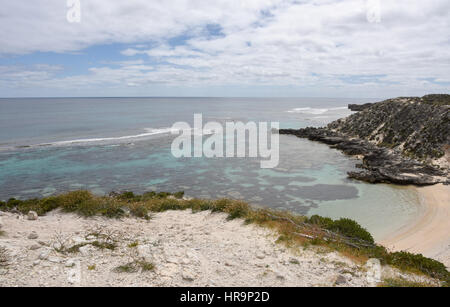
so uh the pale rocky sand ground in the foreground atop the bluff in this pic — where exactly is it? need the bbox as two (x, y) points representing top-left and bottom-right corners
(0, 211), (432, 287)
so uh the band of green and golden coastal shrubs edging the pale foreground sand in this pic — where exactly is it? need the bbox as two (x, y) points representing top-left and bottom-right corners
(0, 191), (450, 285)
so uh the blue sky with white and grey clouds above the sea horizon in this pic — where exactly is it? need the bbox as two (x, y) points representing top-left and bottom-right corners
(0, 0), (450, 98)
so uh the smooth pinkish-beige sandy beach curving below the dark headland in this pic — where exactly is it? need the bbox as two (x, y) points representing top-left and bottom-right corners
(379, 184), (450, 267)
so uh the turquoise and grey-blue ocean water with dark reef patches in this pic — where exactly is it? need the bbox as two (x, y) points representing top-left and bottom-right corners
(0, 98), (422, 239)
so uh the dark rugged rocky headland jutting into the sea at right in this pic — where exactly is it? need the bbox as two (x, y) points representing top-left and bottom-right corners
(280, 95), (450, 186)
